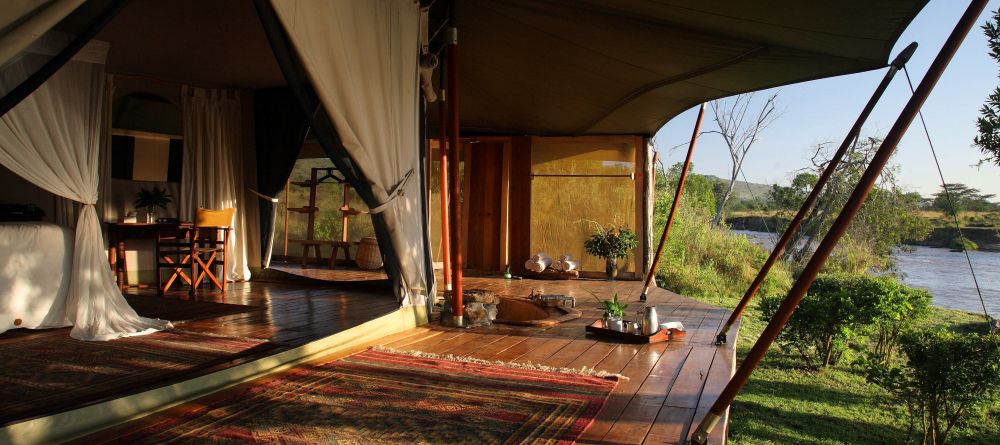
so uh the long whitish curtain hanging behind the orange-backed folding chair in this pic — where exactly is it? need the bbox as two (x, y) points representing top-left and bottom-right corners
(180, 87), (250, 281)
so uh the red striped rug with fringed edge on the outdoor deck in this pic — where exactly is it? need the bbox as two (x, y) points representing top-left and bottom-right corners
(107, 350), (617, 444)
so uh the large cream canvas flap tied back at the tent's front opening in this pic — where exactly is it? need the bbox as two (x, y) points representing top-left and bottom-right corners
(271, 0), (433, 305)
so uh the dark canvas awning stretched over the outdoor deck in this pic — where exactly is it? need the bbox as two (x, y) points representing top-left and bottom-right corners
(438, 0), (926, 135)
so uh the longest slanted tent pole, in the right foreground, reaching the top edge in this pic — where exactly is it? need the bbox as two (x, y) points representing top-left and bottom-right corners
(691, 0), (987, 444)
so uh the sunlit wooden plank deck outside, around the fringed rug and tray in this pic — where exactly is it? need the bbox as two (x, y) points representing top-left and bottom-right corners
(81, 267), (735, 444)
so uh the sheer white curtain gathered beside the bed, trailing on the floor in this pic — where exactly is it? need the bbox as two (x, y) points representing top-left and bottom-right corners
(0, 42), (170, 340)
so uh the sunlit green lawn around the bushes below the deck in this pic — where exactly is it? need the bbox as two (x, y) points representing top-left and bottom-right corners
(694, 286), (1000, 445)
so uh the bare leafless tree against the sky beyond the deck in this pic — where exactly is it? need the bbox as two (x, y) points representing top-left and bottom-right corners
(706, 93), (780, 225)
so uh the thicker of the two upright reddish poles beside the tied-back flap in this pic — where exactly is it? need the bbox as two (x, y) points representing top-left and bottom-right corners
(445, 21), (465, 327)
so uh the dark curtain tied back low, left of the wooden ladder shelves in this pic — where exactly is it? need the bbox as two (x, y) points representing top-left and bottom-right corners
(253, 88), (309, 267)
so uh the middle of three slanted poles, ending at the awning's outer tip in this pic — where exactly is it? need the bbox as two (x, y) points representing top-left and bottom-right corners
(715, 42), (917, 345)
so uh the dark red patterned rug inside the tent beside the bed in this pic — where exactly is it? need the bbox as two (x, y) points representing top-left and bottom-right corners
(0, 328), (270, 424)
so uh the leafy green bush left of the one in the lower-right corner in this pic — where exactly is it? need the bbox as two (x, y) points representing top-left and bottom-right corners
(761, 274), (930, 369)
